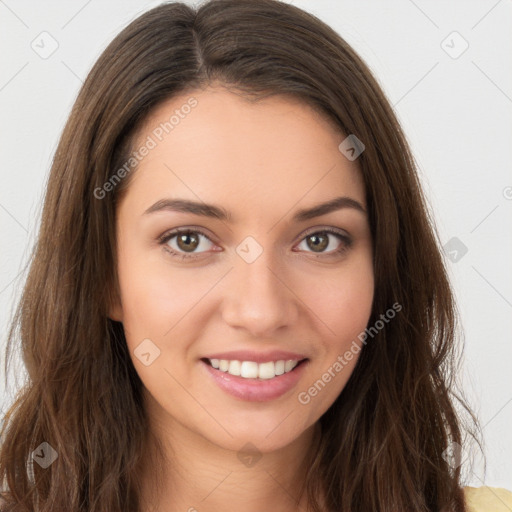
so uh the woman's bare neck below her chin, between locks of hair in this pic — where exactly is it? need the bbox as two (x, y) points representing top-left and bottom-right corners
(136, 398), (319, 512)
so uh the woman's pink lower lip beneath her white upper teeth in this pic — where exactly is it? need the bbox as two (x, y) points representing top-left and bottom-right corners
(200, 360), (308, 402)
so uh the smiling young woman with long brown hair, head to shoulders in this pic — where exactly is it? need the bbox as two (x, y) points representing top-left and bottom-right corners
(0, 0), (510, 512)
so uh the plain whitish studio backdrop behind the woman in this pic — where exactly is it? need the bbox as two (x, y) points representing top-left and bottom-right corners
(0, 0), (512, 490)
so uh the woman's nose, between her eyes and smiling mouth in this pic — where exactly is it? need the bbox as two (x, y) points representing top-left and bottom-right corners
(223, 251), (300, 338)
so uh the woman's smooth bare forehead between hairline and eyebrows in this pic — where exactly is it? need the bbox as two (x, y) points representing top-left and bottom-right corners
(122, 88), (364, 217)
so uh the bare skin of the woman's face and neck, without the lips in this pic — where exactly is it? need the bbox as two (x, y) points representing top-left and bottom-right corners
(110, 87), (374, 512)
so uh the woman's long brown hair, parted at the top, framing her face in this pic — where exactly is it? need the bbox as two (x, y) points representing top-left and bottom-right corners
(0, 0), (476, 512)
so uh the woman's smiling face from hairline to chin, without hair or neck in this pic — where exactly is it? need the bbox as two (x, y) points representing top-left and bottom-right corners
(110, 88), (374, 452)
